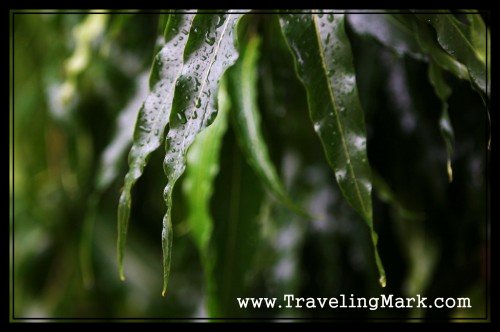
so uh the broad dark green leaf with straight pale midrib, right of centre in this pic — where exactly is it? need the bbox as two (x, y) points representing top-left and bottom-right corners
(280, 14), (386, 287)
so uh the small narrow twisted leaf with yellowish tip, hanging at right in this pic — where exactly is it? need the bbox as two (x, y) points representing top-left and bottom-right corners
(428, 61), (455, 182)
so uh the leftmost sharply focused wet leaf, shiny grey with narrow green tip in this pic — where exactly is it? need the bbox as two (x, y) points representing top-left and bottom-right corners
(117, 14), (194, 280)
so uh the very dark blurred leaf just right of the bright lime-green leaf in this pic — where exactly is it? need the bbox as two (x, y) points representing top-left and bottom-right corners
(208, 131), (266, 317)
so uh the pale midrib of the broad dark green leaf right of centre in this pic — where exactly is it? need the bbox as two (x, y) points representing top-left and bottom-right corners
(311, 14), (368, 217)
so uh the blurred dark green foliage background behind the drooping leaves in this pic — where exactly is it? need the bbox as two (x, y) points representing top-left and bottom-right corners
(11, 11), (489, 319)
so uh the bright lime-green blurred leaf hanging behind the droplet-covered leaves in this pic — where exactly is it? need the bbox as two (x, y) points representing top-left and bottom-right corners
(183, 81), (230, 317)
